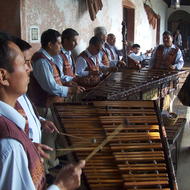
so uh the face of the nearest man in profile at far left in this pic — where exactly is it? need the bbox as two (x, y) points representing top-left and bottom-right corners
(7, 42), (31, 96)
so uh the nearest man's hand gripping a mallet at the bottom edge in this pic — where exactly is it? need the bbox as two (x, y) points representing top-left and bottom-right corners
(54, 160), (85, 190)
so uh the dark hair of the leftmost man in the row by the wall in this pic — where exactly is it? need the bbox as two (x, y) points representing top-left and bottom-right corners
(41, 29), (61, 48)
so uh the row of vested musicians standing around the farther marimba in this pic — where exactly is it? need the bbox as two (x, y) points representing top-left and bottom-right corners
(29, 27), (184, 107)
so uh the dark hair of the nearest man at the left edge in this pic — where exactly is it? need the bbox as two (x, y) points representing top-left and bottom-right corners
(0, 36), (13, 72)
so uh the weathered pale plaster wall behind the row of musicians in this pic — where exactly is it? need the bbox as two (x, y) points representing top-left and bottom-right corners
(21, 0), (167, 53)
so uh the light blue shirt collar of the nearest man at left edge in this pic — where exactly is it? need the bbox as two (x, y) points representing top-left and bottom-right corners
(0, 101), (26, 131)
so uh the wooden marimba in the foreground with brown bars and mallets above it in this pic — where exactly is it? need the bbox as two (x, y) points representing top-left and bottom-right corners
(53, 101), (177, 190)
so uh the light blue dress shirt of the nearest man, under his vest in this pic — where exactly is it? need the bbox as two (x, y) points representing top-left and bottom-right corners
(0, 101), (59, 190)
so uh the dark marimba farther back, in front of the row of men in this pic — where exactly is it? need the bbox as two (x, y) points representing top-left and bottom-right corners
(83, 68), (188, 101)
